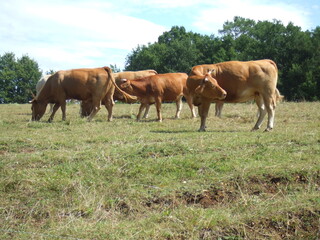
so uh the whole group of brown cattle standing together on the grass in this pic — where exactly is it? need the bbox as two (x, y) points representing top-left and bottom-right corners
(31, 59), (282, 131)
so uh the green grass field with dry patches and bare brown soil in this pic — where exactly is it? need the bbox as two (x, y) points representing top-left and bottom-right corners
(0, 102), (320, 239)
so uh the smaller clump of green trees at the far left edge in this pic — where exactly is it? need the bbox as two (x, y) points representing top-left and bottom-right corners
(0, 53), (42, 103)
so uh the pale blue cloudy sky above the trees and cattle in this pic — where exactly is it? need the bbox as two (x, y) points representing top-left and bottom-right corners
(0, 0), (320, 74)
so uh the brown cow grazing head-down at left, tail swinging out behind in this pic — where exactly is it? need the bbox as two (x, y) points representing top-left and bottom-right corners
(31, 67), (135, 122)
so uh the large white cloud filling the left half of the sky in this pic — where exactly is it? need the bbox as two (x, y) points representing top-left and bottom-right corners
(0, 1), (166, 70)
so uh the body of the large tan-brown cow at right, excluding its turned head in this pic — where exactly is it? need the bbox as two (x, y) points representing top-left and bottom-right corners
(187, 59), (281, 131)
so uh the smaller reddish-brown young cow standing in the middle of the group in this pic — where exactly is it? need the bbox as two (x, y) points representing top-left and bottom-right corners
(120, 73), (195, 122)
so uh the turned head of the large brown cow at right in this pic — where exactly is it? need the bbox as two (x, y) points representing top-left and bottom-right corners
(195, 71), (227, 100)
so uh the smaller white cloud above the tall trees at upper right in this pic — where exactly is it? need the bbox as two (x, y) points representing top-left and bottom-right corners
(193, 0), (310, 33)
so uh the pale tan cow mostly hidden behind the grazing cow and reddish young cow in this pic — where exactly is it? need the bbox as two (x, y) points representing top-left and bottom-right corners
(80, 69), (158, 118)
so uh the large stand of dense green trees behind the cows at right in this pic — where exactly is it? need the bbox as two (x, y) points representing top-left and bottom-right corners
(126, 17), (320, 100)
